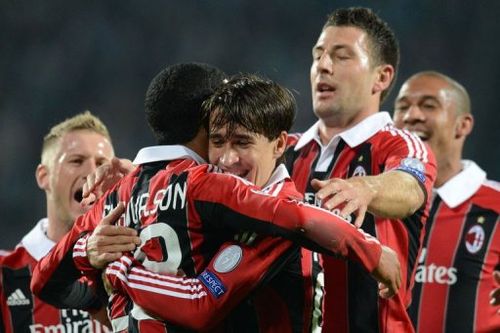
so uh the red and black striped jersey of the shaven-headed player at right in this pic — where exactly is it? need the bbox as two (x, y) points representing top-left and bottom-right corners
(410, 161), (500, 332)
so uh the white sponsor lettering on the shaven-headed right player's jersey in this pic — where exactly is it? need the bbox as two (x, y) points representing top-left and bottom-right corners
(415, 248), (457, 285)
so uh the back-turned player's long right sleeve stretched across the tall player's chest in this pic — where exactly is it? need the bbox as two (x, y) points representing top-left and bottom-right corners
(191, 166), (382, 272)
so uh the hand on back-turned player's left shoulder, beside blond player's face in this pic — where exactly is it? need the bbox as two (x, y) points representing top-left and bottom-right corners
(81, 157), (135, 207)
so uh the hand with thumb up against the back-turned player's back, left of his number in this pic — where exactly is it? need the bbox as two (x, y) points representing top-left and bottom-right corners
(87, 202), (141, 269)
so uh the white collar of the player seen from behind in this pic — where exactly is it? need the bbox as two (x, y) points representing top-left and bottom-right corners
(133, 145), (207, 165)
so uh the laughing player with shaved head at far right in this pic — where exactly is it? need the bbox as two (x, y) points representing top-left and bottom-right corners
(394, 71), (500, 332)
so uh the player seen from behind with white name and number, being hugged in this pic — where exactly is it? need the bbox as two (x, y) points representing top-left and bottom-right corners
(32, 64), (399, 331)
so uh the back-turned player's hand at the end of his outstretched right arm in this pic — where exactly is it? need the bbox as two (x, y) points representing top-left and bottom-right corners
(372, 245), (402, 298)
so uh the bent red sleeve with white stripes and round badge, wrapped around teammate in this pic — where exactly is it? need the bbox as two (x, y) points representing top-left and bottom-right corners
(106, 237), (292, 331)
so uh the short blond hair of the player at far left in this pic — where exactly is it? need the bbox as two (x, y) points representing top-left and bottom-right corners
(41, 111), (111, 165)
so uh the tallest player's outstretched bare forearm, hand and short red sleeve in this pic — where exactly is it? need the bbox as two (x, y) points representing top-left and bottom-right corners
(311, 132), (436, 227)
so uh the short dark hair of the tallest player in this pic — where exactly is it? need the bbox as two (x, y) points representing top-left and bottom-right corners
(323, 7), (399, 102)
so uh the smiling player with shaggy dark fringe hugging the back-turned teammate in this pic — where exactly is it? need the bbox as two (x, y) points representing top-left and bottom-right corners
(100, 75), (398, 332)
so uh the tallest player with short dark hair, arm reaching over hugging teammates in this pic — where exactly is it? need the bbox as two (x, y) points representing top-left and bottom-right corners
(286, 8), (436, 332)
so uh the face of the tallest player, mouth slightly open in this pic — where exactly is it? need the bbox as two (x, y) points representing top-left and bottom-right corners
(311, 27), (377, 121)
